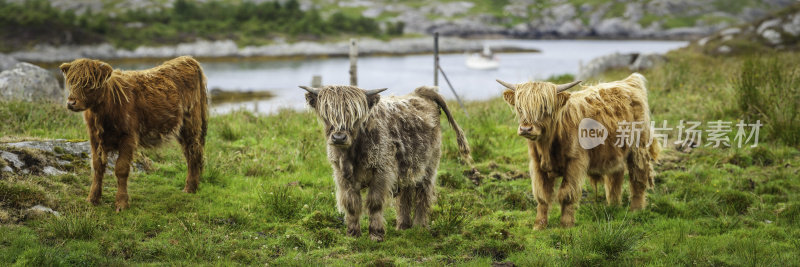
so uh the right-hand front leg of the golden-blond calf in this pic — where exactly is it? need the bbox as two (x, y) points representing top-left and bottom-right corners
(558, 158), (588, 227)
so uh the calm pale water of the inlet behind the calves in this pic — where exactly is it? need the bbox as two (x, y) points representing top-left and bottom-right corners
(115, 40), (687, 113)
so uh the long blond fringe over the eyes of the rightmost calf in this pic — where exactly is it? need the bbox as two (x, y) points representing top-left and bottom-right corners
(514, 82), (556, 123)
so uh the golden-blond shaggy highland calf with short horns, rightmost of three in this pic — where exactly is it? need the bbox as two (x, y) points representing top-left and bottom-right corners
(497, 73), (659, 230)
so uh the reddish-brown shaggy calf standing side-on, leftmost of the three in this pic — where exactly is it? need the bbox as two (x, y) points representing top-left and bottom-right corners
(60, 56), (208, 212)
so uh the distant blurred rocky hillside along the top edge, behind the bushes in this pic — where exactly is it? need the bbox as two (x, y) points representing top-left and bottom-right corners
(13, 0), (797, 39)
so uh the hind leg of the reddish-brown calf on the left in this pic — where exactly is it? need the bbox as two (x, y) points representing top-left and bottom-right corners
(179, 121), (204, 193)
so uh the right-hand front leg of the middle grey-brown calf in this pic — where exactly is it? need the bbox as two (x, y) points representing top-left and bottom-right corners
(367, 177), (391, 242)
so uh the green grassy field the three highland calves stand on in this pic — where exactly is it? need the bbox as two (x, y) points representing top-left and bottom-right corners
(0, 52), (800, 266)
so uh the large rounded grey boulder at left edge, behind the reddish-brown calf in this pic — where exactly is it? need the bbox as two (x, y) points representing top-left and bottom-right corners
(0, 62), (64, 102)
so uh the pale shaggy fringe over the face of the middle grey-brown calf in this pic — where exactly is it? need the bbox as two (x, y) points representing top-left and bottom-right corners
(317, 86), (369, 130)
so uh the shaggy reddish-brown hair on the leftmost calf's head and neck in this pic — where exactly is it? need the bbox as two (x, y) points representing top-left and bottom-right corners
(64, 64), (129, 104)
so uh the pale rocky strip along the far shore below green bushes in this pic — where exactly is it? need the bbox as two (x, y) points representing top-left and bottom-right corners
(8, 37), (538, 63)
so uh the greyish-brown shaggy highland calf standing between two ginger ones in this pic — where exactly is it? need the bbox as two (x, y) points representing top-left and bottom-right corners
(301, 86), (471, 241)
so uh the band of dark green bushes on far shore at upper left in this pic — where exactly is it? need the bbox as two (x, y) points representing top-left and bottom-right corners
(0, 0), (403, 51)
